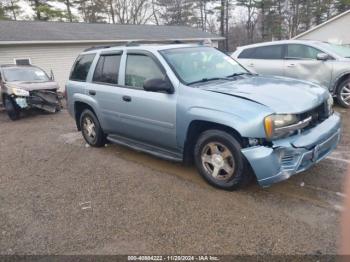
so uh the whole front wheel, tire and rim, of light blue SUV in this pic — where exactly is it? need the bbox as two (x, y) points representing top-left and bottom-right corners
(194, 130), (251, 190)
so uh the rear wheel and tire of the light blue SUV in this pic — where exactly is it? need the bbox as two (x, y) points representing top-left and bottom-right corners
(79, 109), (106, 147)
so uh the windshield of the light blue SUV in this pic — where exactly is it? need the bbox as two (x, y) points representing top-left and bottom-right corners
(161, 47), (249, 84)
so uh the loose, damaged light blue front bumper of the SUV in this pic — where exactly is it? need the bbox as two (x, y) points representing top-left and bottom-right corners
(242, 113), (341, 187)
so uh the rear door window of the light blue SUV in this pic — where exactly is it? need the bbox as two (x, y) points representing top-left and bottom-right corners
(93, 54), (121, 84)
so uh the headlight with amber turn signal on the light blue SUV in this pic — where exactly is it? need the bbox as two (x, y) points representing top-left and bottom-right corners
(264, 114), (299, 140)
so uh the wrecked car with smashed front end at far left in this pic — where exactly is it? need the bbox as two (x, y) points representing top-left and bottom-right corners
(0, 65), (62, 120)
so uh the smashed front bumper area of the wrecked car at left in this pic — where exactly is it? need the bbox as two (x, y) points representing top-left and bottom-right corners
(14, 90), (63, 113)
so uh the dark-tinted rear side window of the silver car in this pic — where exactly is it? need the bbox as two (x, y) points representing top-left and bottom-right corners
(238, 45), (283, 60)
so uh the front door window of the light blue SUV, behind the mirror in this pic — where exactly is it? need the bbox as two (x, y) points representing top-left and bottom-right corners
(125, 54), (165, 89)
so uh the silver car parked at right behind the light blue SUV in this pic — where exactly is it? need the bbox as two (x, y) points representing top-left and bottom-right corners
(232, 40), (350, 108)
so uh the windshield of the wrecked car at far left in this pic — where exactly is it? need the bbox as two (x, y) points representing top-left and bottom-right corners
(3, 67), (49, 82)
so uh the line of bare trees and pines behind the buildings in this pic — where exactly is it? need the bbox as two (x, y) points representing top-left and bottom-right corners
(0, 0), (350, 50)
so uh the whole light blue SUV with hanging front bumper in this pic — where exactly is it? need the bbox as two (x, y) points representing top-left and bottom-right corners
(66, 45), (341, 189)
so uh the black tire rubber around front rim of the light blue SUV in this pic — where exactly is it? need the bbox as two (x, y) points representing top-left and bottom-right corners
(194, 130), (248, 190)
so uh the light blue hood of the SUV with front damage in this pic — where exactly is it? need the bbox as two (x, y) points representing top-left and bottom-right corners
(200, 76), (328, 113)
